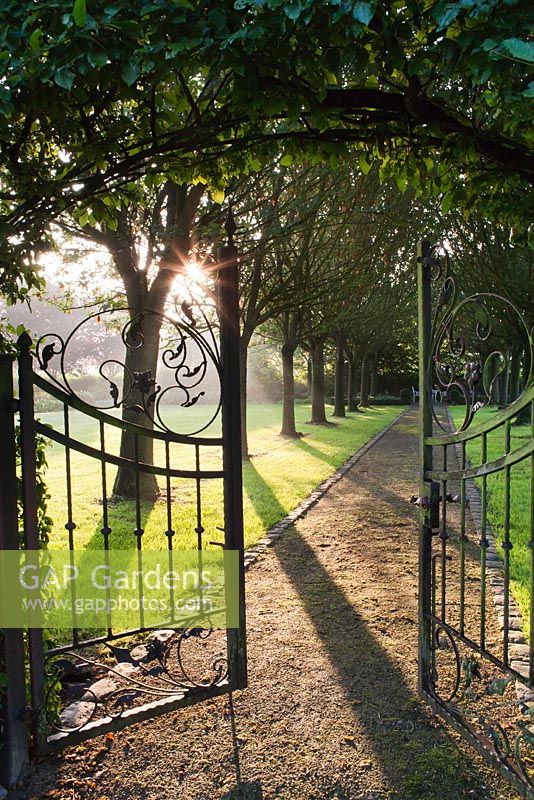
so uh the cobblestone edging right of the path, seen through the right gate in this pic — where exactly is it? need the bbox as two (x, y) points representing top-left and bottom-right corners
(447, 408), (534, 702)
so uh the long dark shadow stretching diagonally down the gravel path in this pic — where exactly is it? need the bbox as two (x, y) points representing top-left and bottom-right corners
(243, 438), (498, 800)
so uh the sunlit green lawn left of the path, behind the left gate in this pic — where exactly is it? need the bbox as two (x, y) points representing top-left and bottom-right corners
(39, 403), (402, 549)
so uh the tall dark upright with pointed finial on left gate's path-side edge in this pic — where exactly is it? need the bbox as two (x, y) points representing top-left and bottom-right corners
(217, 207), (247, 689)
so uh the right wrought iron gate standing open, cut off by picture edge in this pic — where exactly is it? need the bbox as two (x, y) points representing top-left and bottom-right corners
(417, 242), (534, 798)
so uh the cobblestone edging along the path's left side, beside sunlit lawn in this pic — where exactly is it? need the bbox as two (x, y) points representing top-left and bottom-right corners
(245, 406), (411, 570)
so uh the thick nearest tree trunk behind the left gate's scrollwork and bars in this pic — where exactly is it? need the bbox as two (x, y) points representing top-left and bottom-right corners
(113, 314), (161, 500)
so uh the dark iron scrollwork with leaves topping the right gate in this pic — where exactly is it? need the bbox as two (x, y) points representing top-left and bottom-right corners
(421, 244), (534, 433)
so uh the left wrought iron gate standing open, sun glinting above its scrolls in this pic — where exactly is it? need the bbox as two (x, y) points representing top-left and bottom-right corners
(0, 219), (247, 782)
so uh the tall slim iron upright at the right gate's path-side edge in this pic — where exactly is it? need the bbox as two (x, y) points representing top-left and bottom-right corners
(417, 241), (432, 693)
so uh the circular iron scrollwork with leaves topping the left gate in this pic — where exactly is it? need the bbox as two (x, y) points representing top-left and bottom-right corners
(36, 302), (221, 436)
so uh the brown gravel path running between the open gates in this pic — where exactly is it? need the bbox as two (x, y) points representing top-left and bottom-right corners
(17, 412), (514, 800)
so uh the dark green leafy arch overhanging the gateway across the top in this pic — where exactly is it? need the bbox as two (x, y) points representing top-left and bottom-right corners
(0, 0), (534, 295)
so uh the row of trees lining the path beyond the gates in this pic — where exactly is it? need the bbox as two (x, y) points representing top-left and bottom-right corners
(17, 155), (532, 496)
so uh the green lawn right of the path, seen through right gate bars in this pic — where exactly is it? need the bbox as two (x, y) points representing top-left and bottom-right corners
(451, 407), (531, 630)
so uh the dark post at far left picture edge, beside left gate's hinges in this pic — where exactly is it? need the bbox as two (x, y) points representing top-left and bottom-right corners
(0, 353), (28, 786)
